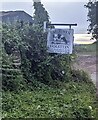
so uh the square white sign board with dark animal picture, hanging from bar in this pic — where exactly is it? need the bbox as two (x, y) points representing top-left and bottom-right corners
(47, 29), (74, 54)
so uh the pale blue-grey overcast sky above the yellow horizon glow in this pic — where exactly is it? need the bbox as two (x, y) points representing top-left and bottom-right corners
(0, 0), (88, 34)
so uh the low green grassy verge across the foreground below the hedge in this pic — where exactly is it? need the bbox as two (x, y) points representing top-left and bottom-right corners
(3, 81), (96, 119)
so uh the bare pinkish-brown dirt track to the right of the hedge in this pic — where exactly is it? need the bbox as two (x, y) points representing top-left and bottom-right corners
(74, 54), (97, 85)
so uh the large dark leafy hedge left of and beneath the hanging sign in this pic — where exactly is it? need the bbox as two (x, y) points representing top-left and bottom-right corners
(2, 23), (71, 90)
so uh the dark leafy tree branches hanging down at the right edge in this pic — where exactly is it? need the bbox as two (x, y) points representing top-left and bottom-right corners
(85, 2), (98, 40)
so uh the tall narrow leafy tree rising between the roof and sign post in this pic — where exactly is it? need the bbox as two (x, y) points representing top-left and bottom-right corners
(33, 0), (49, 27)
